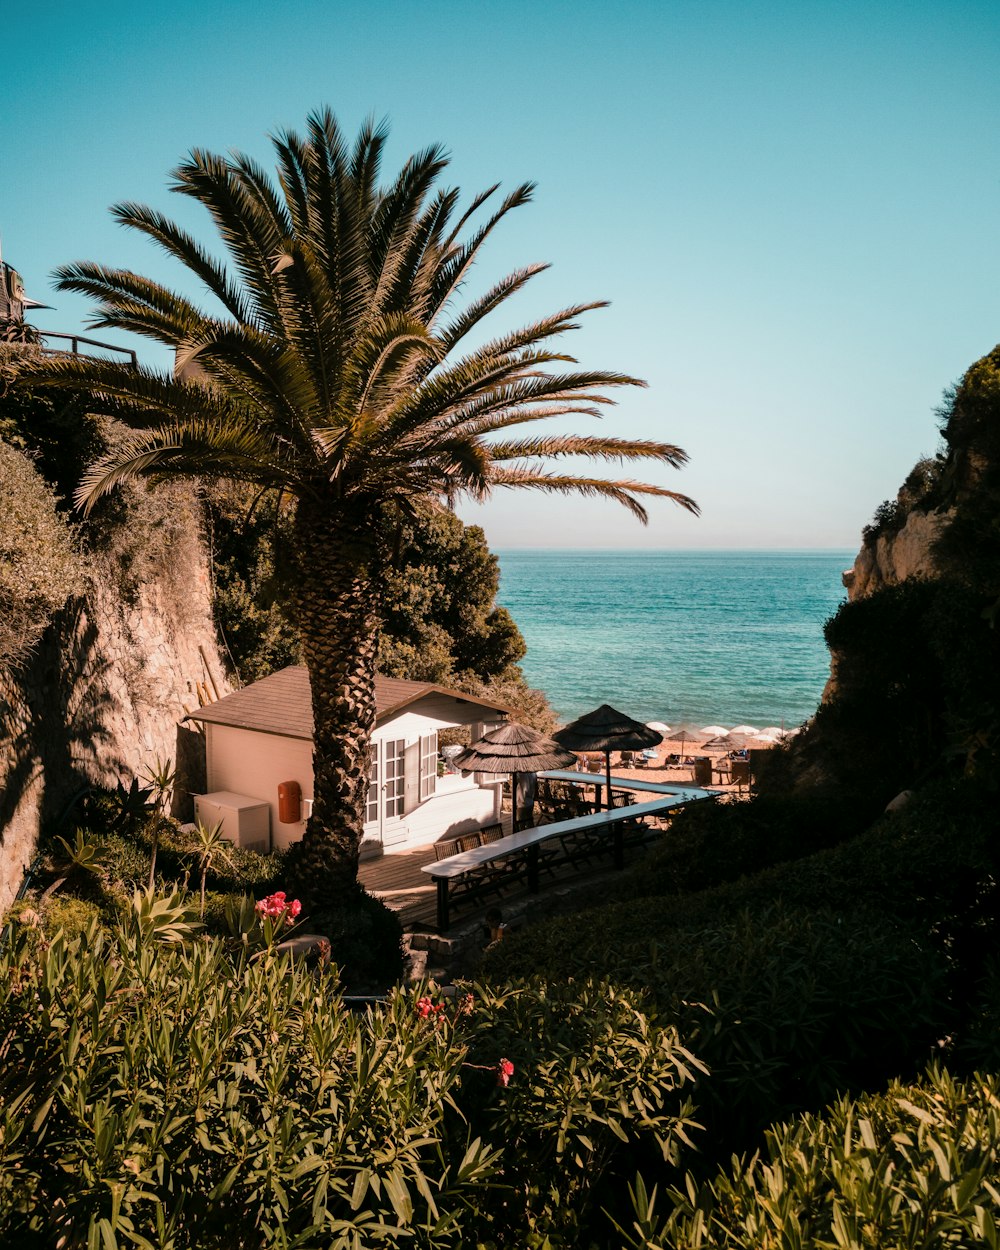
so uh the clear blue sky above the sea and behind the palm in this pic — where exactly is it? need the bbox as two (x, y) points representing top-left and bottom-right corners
(0, 0), (1000, 548)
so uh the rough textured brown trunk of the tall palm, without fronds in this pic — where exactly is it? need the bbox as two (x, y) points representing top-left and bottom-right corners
(294, 503), (380, 911)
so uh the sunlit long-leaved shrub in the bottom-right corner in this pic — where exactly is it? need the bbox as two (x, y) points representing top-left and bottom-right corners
(620, 1070), (1000, 1250)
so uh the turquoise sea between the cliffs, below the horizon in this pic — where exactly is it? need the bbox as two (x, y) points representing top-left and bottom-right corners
(498, 550), (855, 728)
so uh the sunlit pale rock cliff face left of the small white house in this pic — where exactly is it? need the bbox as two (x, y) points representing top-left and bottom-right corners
(0, 489), (230, 910)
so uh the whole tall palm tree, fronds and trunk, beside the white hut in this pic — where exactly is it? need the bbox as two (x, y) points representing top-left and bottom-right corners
(35, 111), (698, 905)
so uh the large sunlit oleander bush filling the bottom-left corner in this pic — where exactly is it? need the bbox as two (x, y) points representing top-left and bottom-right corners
(0, 928), (491, 1250)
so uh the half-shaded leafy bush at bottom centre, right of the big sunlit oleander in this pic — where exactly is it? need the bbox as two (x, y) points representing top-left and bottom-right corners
(461, 980), (700, 1246)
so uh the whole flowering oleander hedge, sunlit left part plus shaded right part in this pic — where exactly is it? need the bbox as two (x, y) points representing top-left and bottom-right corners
(0, 910), (698, 1250)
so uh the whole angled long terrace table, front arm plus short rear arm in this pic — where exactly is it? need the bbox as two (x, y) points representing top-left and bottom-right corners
(420, 785), (715, 933)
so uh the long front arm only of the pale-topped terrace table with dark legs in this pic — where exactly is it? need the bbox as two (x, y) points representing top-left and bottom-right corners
(420, 793), (695, 933)
